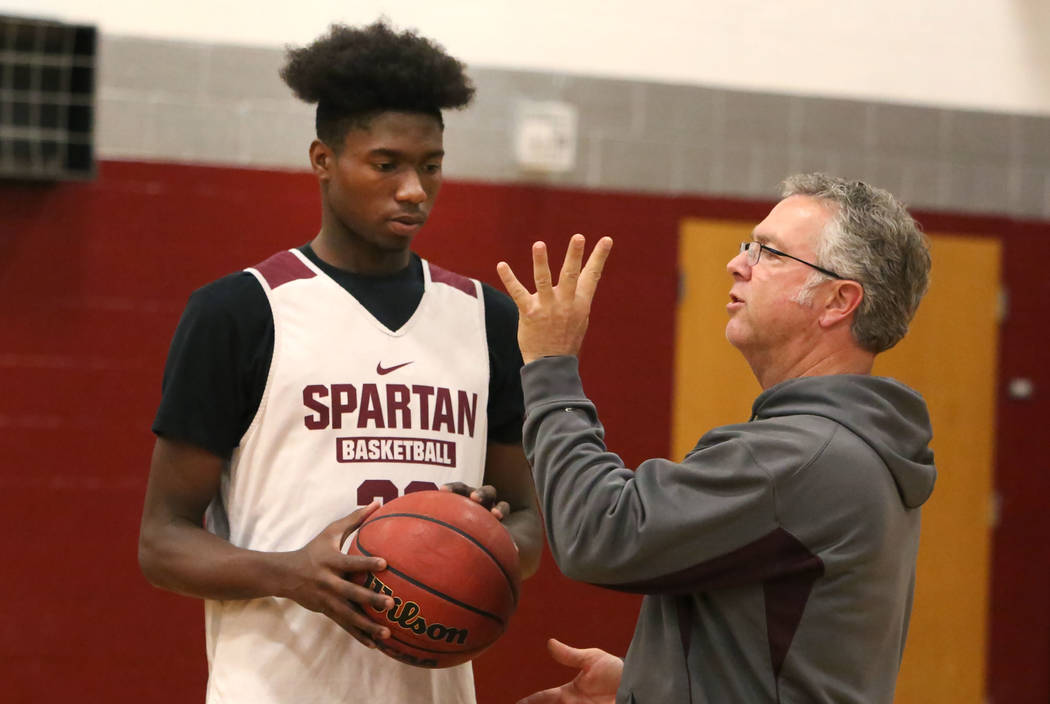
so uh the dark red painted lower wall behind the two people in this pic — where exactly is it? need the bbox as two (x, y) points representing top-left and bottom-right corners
(0, 162), (1050, 704)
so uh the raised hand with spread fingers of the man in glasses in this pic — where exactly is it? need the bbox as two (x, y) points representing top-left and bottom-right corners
(496, 234), (612, 364)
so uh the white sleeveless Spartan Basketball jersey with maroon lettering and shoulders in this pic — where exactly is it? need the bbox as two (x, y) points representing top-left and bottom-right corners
(206, 250), (489, 704)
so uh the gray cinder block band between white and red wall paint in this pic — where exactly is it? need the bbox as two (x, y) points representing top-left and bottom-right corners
(96, 36), (1050, 220)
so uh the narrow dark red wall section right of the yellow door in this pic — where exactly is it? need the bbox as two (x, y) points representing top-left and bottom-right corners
(989, 223), (1050, 704)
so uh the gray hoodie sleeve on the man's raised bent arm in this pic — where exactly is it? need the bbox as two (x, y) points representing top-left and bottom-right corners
(522, 356), (777, 594)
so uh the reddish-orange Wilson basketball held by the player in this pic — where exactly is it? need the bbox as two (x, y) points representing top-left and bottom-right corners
(348, 491), (521, 667)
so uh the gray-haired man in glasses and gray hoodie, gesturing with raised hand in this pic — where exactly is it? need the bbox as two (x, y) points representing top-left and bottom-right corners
(499, 174), (937, 704)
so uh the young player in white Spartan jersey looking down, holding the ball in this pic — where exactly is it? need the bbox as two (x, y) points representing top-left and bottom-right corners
(139, 22), (542, 704)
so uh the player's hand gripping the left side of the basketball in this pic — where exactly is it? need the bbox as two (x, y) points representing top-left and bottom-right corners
(275, 501), (393, 648)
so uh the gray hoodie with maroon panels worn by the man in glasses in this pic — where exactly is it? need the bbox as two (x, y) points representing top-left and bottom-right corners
(522, 357), (937, 704)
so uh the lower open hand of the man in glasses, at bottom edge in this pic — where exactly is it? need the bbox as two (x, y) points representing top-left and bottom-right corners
(518, 638), (624, 704)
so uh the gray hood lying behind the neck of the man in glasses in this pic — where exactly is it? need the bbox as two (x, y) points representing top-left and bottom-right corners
(752, 374), (937, 509)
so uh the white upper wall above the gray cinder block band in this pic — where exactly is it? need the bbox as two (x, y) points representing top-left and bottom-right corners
(6, 0), (1050, 115)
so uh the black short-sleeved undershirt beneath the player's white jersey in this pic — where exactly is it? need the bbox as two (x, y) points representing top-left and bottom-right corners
(153, 245), (524, 459)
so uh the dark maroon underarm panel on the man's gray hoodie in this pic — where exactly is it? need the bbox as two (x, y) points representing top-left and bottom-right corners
(599, 527), (824, 676)
